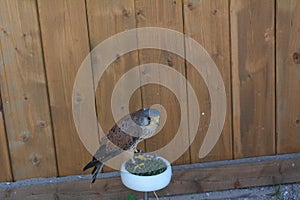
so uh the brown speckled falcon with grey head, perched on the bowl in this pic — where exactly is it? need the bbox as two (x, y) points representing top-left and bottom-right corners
(83, 108), (160, 184)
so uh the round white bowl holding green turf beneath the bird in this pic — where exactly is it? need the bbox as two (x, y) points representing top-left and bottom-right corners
(121, 156), (172, 192)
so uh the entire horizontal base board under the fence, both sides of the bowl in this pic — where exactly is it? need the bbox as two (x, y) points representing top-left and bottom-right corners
(0, 154), (300, 200)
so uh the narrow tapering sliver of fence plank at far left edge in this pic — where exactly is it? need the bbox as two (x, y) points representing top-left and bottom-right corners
(0, 91), (13, 182)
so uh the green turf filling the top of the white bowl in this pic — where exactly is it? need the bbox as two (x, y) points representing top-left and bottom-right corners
(125, 154), (167, 176)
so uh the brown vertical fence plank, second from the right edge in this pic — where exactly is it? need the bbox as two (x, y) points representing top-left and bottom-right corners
(230, 0), (275, 158)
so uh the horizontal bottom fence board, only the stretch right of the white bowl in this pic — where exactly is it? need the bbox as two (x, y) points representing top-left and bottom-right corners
(164, 155), (300, 195)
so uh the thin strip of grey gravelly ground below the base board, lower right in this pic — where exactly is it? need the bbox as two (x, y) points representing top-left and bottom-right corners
(149, 183), (300, 200)
